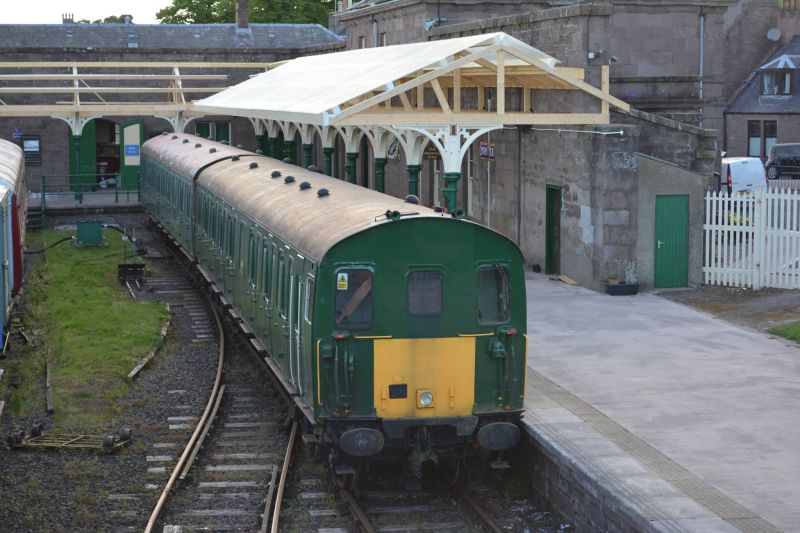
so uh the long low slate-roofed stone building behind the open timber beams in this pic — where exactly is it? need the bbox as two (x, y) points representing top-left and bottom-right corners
(0, 11), (343, 190)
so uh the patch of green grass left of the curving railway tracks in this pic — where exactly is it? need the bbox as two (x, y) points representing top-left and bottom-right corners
(12, 230), (167, 429)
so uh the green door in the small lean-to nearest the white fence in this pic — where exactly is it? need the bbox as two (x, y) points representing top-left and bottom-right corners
(655, 194), (689, 288)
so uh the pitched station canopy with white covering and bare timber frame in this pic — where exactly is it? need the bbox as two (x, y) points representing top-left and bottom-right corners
(193, 33), (629, 127)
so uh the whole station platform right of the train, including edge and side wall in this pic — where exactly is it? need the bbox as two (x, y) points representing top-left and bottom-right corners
(524, 273), (800, 532)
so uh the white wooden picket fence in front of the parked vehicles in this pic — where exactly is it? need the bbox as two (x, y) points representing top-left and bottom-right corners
(703, 188), (800, 289)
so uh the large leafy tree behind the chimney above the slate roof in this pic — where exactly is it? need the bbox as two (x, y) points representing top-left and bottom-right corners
(156, 0), (334, 25)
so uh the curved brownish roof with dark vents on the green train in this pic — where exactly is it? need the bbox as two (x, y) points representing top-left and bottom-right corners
(144, 134), (462, 261)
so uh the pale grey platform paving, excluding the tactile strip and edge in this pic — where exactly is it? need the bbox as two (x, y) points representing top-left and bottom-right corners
(526, 274), (800, 531)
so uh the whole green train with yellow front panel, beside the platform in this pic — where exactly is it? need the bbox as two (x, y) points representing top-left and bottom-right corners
(141, 134), (527, 479)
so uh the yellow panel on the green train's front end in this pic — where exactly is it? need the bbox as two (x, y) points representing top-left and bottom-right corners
(374, 337), (475, 418)
